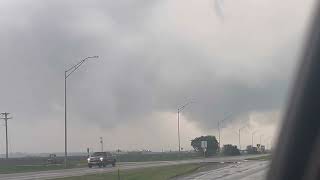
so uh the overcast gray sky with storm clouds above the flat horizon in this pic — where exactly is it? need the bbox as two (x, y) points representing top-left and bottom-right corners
(0, 0), (313, 153)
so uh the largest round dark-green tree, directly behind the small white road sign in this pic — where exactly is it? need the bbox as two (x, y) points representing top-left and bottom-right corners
(191, 136), (218, 156)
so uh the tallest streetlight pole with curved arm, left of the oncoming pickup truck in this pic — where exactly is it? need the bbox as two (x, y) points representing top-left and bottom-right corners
(64, 56), (99, 168)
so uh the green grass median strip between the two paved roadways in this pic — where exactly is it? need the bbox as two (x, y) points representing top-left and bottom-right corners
(57, 164), (201, 180)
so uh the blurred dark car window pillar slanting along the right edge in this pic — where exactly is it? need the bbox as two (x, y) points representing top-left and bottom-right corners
(267, 3), (320, 180)
